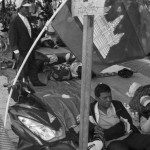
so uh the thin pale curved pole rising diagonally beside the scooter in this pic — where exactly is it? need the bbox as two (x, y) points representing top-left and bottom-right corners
(4, 0), (67, 127)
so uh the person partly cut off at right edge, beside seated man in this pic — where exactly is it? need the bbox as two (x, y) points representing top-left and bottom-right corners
(129, 84), (150, 134)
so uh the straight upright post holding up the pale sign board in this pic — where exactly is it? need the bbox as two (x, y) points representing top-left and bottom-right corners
(79, 15), (94, 150)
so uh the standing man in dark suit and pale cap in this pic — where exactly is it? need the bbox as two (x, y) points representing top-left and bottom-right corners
(9, 0), (45, 86)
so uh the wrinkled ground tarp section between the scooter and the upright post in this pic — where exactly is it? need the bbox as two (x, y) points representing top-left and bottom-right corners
(34, 81), (92, 129)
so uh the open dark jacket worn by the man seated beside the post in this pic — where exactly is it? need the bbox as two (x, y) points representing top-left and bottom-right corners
(90, 100), (139, 141)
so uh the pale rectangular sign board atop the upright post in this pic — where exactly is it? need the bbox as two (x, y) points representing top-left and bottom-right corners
(72, 0), (105, 16)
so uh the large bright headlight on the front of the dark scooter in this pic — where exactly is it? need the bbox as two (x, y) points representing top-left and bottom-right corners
(18, 116), (61, 141)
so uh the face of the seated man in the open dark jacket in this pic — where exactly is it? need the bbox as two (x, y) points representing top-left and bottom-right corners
(97, 92), (112, 109)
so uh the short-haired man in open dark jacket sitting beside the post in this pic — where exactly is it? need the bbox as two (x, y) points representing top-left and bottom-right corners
(89, 83), (150, 150)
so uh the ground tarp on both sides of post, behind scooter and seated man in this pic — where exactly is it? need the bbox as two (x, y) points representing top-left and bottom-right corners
(34, 70), (150, 129)
